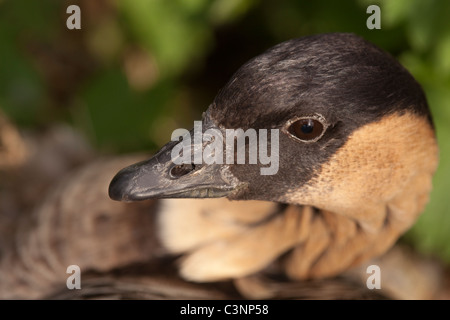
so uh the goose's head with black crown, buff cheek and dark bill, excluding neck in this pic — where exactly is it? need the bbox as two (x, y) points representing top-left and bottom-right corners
(109, 33), (438, 240)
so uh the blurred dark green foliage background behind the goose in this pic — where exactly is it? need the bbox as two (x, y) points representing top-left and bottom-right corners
(0, 0), (450, 262)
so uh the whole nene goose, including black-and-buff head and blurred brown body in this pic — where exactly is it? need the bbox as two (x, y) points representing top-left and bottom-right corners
(0, 34), (439, 299)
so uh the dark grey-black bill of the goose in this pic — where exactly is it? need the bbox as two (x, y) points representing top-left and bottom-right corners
(109, 128), (238, 201)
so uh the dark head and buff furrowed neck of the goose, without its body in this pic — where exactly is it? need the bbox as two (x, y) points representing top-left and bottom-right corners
(109, 33), (438, 282)
